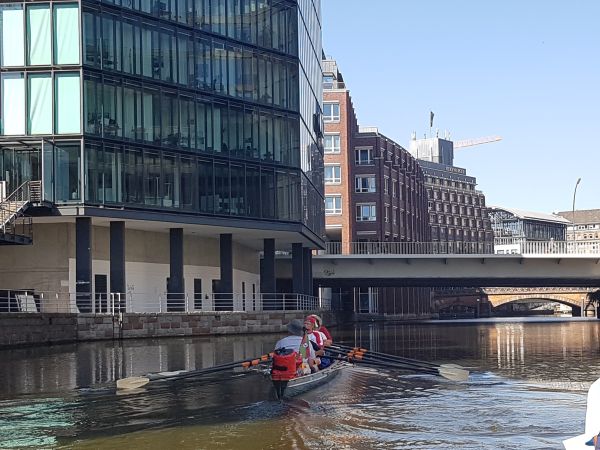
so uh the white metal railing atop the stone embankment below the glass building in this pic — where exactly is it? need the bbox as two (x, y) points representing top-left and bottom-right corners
(0, 290), (330, 315)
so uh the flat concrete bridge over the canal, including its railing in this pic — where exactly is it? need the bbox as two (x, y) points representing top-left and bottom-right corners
(294, 241), (600, 290)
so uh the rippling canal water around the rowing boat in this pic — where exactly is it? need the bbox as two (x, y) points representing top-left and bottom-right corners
(0, 318), (600, 450)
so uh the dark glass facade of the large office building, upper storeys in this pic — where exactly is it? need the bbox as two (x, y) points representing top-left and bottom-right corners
(0, 0), (324, 241)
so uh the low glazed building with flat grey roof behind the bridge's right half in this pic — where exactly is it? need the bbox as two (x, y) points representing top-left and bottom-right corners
(489, 206), (569, 254)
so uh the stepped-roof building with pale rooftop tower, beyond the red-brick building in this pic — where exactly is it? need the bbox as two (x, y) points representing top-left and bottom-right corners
(409, 135), (494, 253)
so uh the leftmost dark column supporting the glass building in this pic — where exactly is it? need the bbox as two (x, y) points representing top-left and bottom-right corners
(75, 217), (92, 313)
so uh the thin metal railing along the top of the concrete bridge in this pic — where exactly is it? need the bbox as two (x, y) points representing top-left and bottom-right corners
(319, 238), (600, 255)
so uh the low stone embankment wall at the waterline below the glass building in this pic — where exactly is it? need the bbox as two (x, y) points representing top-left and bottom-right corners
(0, 311), (341, 347)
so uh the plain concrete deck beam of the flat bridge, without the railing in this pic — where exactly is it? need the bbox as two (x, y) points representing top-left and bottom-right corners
(308, 255), (600, 287)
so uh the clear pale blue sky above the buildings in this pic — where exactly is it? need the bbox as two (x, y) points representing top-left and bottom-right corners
(323, 0), (600, 212)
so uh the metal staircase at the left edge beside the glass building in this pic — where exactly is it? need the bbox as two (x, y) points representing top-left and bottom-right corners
(0, 181), (42, 245)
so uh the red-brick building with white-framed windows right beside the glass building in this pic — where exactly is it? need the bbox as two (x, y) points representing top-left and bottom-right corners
(323, 60), (430, 317)
